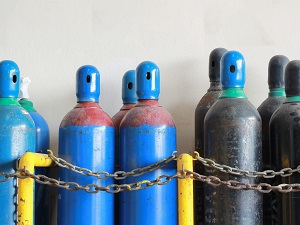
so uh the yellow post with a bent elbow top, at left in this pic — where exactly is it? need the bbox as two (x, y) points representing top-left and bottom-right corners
(17, 152), (53, 225)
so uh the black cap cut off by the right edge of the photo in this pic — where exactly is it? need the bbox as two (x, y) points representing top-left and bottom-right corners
(284, 60), (300, 97)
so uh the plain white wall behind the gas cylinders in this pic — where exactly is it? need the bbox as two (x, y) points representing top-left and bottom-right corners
(0, 0), (300, 223)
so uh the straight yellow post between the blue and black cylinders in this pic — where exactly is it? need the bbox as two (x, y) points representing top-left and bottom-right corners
(177, 154), (194, 225)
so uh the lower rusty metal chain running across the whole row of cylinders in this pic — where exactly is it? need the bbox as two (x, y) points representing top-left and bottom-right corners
(0, 164), (300, 194)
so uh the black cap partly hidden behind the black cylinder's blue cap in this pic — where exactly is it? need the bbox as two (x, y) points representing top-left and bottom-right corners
(209, 48), (227, 82)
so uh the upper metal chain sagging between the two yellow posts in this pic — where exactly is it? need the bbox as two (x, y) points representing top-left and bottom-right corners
(48, 151), (177, 180)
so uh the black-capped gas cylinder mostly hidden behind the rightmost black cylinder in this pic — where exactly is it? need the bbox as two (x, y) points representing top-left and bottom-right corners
(257, 55), (289, 225)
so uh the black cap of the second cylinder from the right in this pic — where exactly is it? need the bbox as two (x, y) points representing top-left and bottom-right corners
(268, 55), (290, 89)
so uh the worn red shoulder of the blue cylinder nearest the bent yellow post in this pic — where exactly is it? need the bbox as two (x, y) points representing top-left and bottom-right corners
(60, 104), (114, 127)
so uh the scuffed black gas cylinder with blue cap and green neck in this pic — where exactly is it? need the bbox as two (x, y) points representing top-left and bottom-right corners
(204, 51), (263, 225)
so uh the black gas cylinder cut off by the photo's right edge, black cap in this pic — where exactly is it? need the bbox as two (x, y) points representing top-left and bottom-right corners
(270, 60), (300, 225)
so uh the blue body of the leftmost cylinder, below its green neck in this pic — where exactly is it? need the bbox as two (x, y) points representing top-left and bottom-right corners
(0, 102), (35, 225)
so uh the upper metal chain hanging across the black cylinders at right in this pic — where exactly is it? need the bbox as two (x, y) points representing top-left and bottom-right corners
(194, 152), (300, 178)
